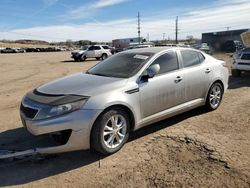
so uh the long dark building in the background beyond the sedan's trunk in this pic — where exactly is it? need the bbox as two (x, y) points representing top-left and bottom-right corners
(202, 29), (248, 50)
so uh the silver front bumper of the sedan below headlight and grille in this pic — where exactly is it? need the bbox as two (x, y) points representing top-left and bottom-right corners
(21, 110), (101, 154)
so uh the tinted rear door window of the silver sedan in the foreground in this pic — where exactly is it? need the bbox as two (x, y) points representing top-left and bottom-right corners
(181, 50), (201, 67)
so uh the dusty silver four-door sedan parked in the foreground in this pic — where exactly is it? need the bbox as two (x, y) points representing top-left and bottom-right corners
(20, 47), (228, 154)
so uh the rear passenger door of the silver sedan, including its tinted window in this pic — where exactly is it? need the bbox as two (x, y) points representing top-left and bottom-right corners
(180, 49), (213, 102)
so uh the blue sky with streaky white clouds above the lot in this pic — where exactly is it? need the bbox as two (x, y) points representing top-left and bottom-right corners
(0, 0), (250, 42)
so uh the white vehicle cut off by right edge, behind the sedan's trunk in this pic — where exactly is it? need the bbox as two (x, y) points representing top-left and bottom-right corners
(232, 49), (250, 77)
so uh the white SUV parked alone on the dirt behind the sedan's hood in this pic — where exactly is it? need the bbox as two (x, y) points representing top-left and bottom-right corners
(71, 45), (112, 61)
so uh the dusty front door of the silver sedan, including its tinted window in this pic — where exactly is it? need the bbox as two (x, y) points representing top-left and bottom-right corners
(139, 51), (183, 118)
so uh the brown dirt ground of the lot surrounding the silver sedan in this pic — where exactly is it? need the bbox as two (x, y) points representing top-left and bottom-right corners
(0, 52), (250, 187)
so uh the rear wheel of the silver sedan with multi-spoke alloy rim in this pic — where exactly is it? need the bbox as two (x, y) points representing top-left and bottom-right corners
(205, 82), (224, 111)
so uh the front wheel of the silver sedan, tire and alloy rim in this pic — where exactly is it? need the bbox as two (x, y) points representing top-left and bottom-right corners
(91, 108), (130, 155)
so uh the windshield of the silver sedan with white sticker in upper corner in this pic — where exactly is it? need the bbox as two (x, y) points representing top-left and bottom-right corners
(87, 53), (153, 78)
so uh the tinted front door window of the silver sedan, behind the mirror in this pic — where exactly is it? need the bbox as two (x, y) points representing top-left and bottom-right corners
(152, 52), (179, 74)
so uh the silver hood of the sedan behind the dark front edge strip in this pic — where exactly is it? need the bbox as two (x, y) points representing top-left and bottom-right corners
(36, 73), (127, 96)
